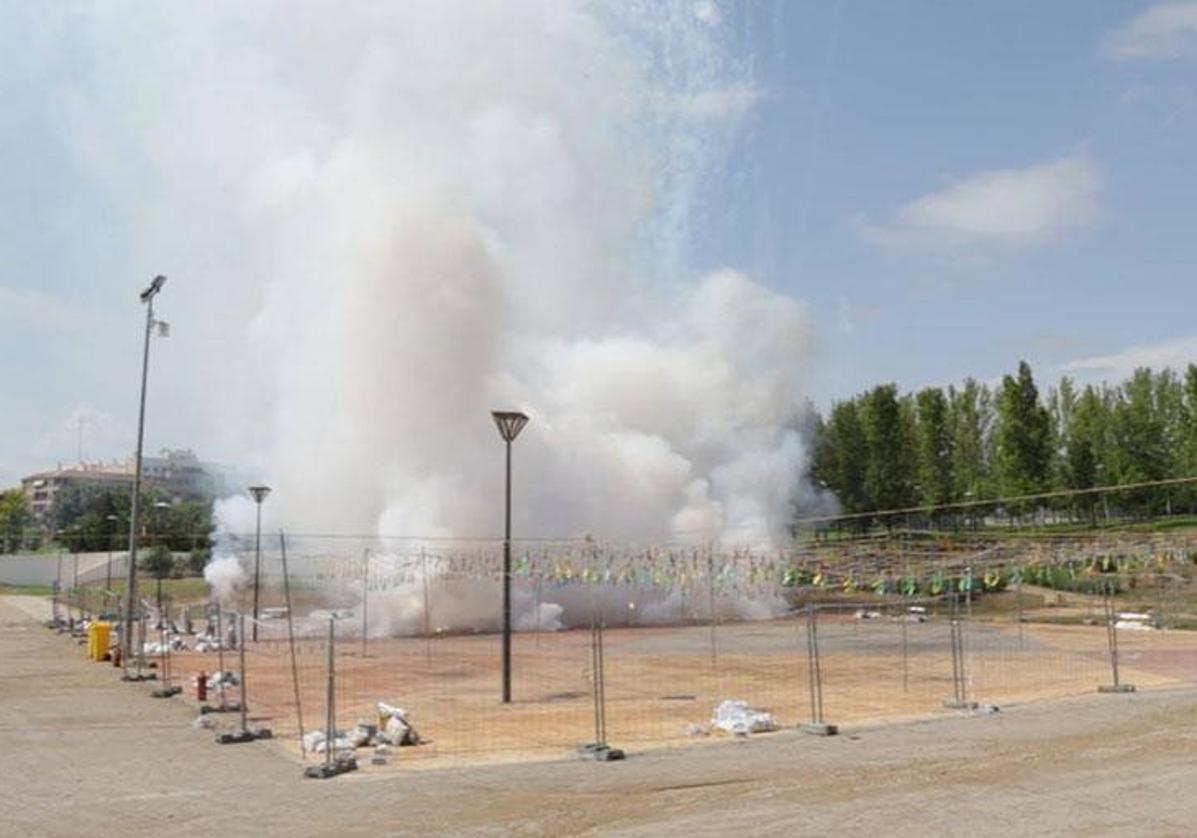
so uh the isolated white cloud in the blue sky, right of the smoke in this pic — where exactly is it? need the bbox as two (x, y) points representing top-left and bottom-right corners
(861, 153), (1102, 249)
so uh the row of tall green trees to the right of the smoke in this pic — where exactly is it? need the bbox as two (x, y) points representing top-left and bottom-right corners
(810, 362), (1197, 518)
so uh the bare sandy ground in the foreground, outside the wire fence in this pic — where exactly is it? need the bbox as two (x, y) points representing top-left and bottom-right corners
(7, 602), (1197, 836)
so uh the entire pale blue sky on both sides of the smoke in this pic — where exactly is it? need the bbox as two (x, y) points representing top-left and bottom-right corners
(0, 0), (1197, 484)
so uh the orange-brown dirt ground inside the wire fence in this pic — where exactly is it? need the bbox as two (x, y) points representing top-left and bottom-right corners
(152, 605), (1197, 769)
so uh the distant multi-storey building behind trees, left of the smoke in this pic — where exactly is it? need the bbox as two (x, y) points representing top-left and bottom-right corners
(20, 449), (224, 529)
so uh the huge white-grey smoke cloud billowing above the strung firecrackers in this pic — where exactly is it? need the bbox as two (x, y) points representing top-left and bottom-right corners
(60, 0), (812, 543)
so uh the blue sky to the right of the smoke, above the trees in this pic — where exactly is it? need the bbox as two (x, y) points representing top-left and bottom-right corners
(705, 1), (1197, 401)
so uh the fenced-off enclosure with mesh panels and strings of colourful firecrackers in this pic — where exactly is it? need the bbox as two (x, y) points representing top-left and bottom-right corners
(51, 535), (1197, 767)
